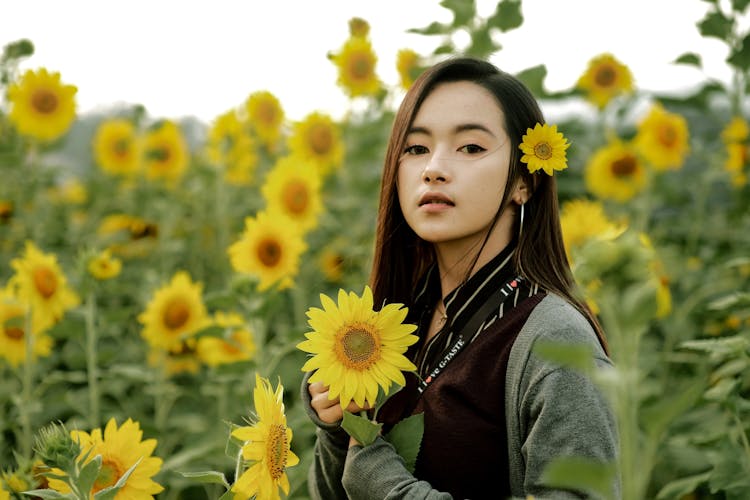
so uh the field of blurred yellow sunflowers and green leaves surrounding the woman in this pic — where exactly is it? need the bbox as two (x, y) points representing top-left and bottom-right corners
(0, 0), (750, 500)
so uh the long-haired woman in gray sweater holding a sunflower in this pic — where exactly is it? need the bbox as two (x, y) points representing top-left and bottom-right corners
(302, 58), (619, 500)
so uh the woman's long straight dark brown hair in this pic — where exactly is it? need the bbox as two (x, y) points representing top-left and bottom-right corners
(370, 57), (608, 351)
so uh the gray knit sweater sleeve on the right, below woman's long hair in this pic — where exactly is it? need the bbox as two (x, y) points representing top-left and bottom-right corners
(506, 297), (620, 499)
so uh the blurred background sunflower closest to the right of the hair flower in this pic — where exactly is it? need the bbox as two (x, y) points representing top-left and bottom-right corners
(584, 141), (646, 202)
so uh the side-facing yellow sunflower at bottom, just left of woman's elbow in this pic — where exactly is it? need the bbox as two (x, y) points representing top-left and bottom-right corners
(232, 373), (299, 500)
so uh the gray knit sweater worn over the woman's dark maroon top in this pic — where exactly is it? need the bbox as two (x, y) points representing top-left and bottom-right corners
(301, 294), (620, 500)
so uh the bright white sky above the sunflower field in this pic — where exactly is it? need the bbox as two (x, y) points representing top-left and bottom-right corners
(0, 0), (730, 120)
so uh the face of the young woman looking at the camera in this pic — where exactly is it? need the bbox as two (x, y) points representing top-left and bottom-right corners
(398, 81), (512, 251)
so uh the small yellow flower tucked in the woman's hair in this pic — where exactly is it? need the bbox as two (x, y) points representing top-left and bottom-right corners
(518, 123), (570, 175)
